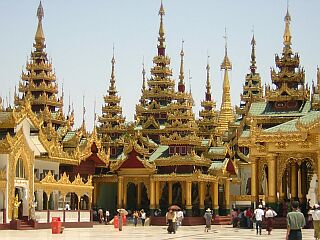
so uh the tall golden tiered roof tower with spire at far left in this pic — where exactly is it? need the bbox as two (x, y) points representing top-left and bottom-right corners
(15, 2), (73, 129)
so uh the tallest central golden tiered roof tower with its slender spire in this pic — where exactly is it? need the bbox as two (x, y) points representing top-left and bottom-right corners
(135, 3), (175, 143)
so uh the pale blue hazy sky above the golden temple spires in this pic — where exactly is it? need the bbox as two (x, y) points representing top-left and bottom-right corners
(0, 0), (320, 129)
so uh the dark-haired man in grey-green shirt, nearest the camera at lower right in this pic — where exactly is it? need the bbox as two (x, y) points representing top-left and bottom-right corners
(287, 201), (306, 240)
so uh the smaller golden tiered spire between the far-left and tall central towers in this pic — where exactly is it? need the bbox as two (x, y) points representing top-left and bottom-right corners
(98, 51), (126, 157)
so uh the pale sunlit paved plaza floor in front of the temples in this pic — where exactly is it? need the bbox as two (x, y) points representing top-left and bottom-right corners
(0, 225), (313, 240)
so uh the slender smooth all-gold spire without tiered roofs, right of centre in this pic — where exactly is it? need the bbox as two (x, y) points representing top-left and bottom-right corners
(219, 29), (234, 132)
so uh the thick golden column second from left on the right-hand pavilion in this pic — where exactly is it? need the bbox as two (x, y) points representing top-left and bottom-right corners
(268, 155), (277, 203)
